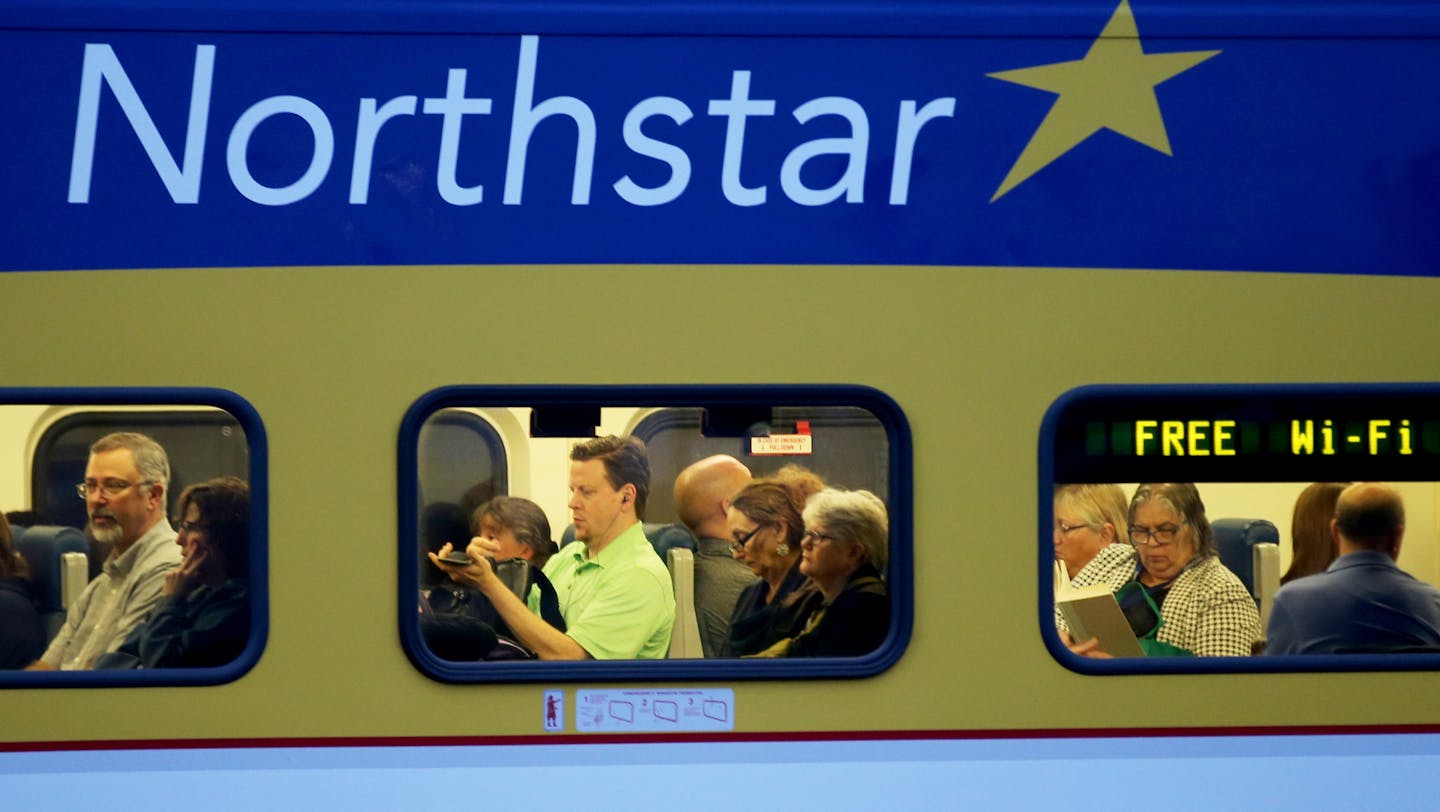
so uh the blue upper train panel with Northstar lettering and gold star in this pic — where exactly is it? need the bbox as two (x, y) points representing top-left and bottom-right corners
(0, 0), (1440, 275)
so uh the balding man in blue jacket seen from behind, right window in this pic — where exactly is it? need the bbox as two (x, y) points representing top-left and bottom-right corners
(1266, 482), (1440, 654)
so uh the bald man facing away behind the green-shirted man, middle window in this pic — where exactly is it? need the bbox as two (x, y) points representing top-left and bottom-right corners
(675, 454), (755, 657)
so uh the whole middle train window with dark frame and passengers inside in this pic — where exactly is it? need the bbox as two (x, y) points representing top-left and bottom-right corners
(399, 386), (913, 682)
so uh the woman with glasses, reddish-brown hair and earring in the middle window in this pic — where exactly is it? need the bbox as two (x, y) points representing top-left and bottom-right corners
(720, 465), (825, 657)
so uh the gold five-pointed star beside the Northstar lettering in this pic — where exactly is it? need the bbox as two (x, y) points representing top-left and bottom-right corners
(986, 0), (1220, 203)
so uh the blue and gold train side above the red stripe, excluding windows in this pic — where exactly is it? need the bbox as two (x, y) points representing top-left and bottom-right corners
(0, 0), (1440, 800)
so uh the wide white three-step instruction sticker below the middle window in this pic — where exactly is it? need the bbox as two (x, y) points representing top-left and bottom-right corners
(575, 688), (734, 733)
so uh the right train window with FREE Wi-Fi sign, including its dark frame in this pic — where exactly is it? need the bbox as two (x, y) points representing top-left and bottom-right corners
(1037, 384), (1440, 674)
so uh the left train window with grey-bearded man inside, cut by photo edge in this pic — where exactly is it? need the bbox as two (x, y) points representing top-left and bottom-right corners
(0, 389), (269, 687)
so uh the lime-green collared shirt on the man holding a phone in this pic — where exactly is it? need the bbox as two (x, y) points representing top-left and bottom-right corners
(528, 523), (675, 659)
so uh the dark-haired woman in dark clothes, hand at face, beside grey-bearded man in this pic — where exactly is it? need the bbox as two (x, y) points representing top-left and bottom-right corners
(95, 477), (251, 668)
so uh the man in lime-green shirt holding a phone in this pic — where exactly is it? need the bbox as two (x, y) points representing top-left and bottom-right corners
(431, 435), (675, 659)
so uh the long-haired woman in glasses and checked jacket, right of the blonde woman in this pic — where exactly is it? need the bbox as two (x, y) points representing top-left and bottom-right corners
(1070, 482), (1260, 657)
